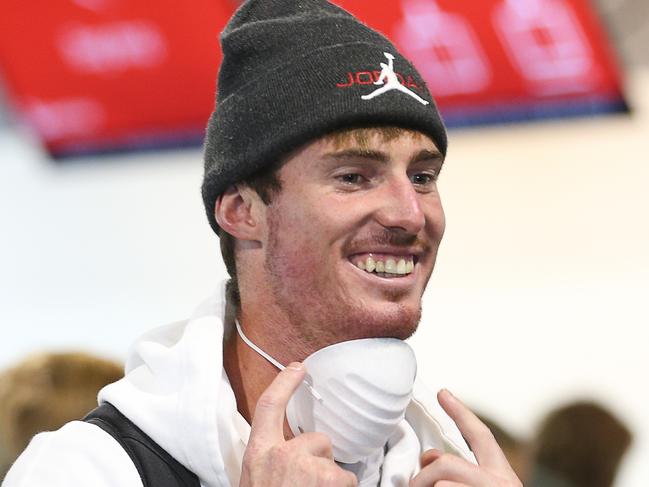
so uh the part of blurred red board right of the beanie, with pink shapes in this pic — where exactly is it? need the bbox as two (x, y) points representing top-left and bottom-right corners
(334, 0), (626, 125)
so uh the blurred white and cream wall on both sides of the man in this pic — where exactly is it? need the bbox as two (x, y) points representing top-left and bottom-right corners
(0, 72), (649, 487)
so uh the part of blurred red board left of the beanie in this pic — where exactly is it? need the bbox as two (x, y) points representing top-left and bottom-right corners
(0, 0), (236, 156)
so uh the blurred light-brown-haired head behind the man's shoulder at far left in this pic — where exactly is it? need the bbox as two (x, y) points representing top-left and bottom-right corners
(0, 352), (124, 479)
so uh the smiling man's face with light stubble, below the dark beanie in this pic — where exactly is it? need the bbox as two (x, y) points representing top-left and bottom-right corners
(264, 131), (445, 349)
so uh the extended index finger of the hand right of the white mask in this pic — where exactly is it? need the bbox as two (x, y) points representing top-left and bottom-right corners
(437, 389), (511, 468)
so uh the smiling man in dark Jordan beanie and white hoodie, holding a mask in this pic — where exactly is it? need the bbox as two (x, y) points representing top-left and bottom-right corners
(3, 0), (520, 487)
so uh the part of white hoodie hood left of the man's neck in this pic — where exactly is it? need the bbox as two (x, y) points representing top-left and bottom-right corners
(99, 285), (250, 487)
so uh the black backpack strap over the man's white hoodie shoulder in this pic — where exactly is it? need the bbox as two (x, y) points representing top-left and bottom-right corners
(83, 402), (200, 487)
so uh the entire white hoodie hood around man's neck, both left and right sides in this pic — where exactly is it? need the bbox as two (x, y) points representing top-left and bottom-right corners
(99, 282), (475, 487)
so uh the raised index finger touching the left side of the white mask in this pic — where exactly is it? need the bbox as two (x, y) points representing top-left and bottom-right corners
(249, 362), (306, 443)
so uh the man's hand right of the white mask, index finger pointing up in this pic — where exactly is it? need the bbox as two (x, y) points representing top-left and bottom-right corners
(410, 390), (523, 487)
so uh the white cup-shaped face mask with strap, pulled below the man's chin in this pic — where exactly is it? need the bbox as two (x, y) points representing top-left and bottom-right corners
(236, 322), (417, 463)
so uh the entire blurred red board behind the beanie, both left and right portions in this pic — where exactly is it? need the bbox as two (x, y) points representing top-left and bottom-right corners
(0, 0), (626, 156)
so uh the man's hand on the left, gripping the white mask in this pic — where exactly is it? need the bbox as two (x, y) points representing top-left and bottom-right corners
(239, 363), (357, 487)
